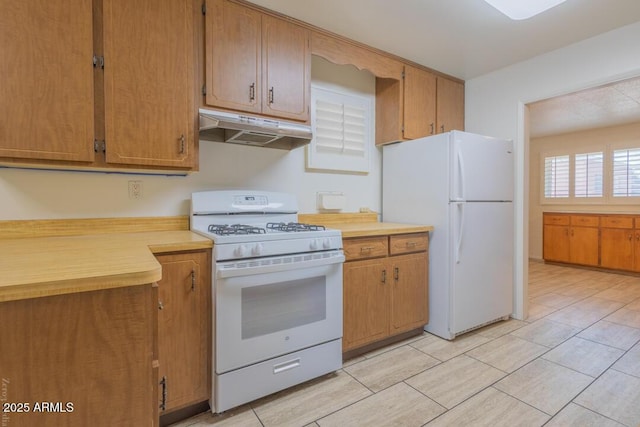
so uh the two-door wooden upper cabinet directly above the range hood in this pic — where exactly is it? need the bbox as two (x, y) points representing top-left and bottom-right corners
(205, 0), (311, 121)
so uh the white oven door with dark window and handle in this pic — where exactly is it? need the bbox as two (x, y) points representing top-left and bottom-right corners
(214, 251), (344, 374)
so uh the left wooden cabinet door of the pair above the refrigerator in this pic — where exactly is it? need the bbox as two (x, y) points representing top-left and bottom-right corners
(403, 65), (436, 139)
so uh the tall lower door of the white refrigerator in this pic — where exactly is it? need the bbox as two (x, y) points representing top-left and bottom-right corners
(449, 202), (513, 335)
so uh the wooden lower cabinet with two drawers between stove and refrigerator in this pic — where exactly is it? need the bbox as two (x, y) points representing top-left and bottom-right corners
(342, 233), (428, 352)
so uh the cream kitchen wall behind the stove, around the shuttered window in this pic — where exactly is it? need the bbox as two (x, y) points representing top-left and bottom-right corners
(0, 58), (381, 220)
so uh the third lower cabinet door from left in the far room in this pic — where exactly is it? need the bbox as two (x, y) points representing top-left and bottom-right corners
(600, 228), (635, 270)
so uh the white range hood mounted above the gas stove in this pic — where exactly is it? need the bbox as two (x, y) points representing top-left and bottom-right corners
(200, 108), (312, 150)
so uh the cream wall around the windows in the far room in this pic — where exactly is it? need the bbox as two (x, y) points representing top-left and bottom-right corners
(529, 123), (640, 259)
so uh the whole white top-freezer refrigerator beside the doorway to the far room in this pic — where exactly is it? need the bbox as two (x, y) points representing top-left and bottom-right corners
(382, 131), (514, 340)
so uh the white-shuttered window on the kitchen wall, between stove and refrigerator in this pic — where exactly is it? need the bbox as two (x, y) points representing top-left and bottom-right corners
(307, 85), (374, 172)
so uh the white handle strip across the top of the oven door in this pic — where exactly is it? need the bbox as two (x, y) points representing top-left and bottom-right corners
(215, 251), (345, 279)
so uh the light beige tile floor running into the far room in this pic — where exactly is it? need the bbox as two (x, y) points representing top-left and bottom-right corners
(174, 262), (640, 427)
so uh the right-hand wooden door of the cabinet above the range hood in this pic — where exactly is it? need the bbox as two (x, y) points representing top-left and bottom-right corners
(262, 15), (311, 121)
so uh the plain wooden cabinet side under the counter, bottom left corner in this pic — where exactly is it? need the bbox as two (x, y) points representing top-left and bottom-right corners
(0, 284), (158, 427)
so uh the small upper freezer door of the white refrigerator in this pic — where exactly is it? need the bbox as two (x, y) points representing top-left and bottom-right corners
(449, 131), (514, 201)
